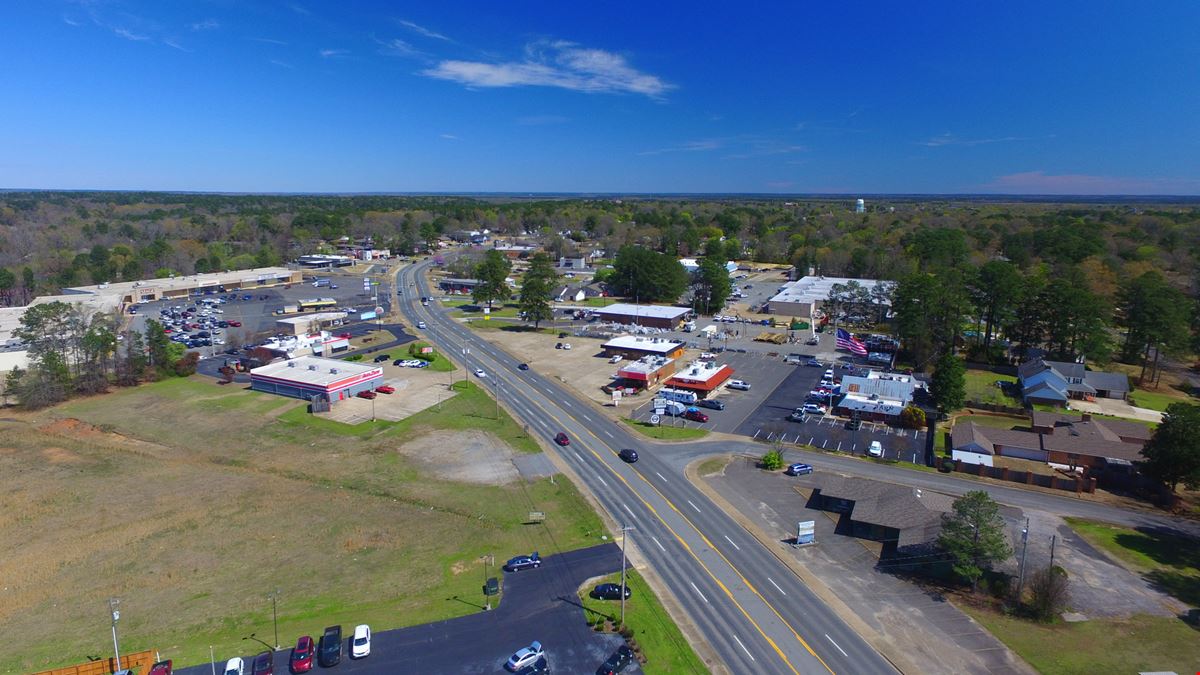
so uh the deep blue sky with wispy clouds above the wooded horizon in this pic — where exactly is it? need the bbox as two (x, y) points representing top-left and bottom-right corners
(0, 0), (1200, 195)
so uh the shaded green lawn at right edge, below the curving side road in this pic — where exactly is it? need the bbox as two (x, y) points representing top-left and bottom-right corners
(1067, 518), (1200, 607)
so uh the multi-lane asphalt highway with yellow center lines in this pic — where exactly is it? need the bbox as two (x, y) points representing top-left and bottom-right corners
(400, 257), (895, 674)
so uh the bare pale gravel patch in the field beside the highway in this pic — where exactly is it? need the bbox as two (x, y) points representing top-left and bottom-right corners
(398, 430), (520, 485)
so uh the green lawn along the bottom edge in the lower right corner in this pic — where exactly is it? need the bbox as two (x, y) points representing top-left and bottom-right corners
(962, 605), (1200, 675)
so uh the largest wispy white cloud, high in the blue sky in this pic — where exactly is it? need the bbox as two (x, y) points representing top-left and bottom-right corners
(421, 41), (674, 98)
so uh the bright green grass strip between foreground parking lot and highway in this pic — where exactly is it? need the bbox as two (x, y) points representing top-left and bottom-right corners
(580, 569), (707, 675)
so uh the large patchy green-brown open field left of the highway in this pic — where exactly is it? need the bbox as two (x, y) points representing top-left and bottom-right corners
(0, 377), (605, 673)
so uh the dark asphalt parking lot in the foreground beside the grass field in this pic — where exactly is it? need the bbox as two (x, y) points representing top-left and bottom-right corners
(176, 544), (641, 675)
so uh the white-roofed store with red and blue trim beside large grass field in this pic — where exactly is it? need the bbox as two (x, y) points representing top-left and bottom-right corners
(250, 357), (383, 402)
